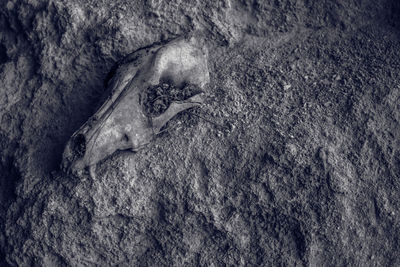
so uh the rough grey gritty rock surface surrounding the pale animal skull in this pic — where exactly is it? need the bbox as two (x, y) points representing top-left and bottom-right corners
(0, 0), (400, 266)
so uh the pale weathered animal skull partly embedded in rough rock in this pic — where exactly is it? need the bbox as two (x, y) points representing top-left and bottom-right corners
(62, 36), (209, 176)
